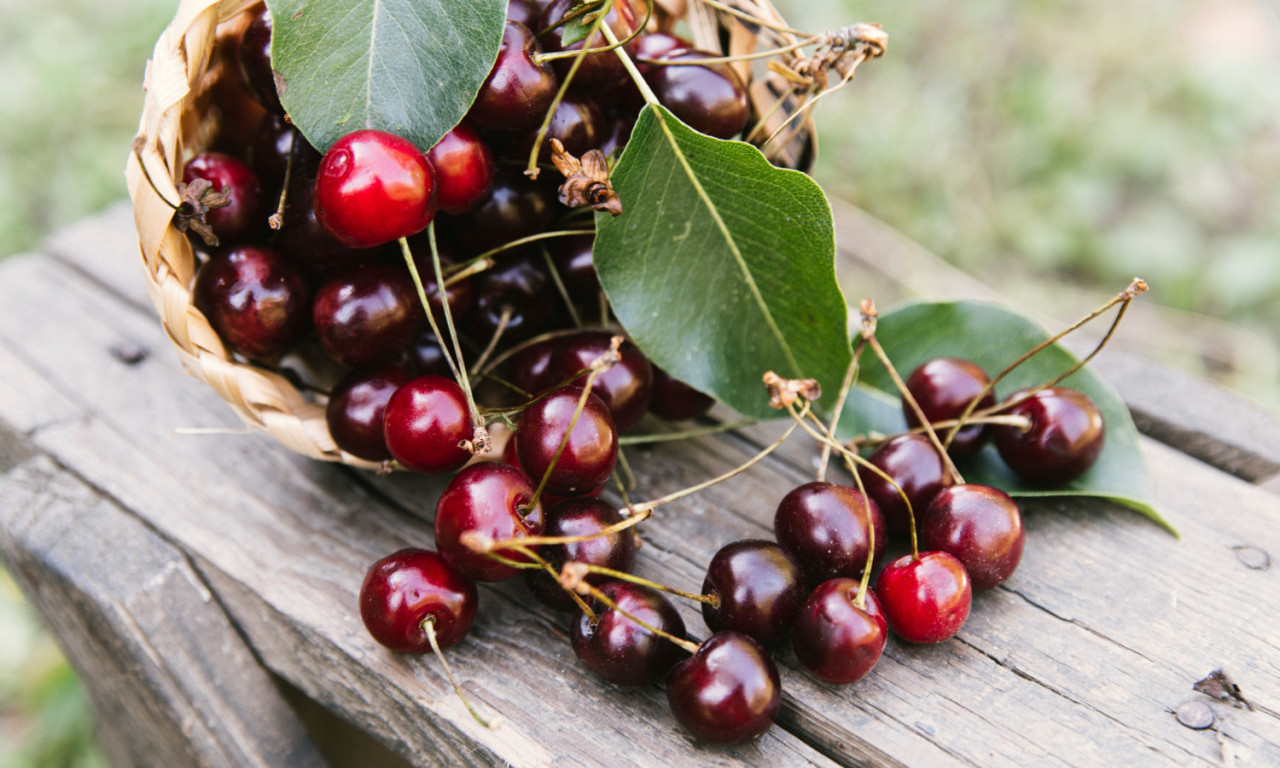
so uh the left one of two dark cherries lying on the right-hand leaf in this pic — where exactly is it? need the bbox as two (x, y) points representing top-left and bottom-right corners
(902, 357), (996, 458)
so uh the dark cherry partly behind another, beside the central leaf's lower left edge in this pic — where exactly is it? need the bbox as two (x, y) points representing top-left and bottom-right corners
(549, 330), (653, 433)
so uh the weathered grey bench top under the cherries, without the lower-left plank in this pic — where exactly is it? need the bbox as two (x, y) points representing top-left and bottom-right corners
(0, 203), (1280, 765)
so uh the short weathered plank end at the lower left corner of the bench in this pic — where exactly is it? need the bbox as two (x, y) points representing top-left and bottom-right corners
(0, 456), (324, 768)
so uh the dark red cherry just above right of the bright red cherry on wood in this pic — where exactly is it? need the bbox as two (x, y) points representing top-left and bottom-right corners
(920, 484), (1025, 589)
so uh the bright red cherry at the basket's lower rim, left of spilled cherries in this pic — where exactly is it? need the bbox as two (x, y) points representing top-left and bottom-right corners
(383, 376), (475, 475)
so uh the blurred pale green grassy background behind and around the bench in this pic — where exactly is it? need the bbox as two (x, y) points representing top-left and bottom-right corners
(0, 0), (1280, 768)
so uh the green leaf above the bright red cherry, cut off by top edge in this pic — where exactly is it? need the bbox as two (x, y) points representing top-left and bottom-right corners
(268, 0), (507, 151)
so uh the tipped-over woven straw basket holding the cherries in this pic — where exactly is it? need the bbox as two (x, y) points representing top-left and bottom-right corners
(125, 0), (814, 468)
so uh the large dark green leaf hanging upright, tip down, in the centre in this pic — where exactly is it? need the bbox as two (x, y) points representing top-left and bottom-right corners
(595, 106), (850, 419)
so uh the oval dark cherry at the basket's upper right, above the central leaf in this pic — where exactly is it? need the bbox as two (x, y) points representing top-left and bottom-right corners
(645, 50), (751, 138)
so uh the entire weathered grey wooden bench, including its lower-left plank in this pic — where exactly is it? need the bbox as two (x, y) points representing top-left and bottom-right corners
(0, 205), (1280, 767)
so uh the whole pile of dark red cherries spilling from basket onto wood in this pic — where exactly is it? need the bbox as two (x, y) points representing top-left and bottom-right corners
(178, 0), (1103, 744)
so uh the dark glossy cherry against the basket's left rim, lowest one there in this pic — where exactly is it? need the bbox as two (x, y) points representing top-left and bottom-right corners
(192, 246), (311, 361)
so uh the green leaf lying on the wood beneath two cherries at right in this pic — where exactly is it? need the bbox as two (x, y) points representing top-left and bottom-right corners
(837, 301), (1178, 535)
